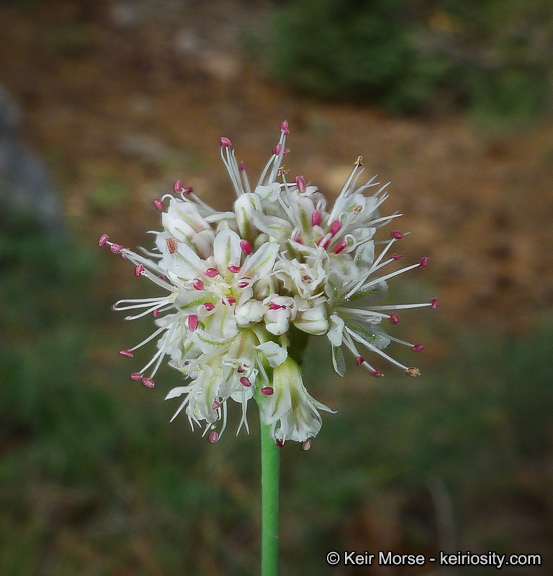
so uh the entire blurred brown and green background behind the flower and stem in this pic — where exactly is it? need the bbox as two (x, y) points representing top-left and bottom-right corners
(0, 0), (553, 576)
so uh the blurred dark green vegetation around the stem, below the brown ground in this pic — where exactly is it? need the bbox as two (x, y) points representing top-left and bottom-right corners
(0, 209), (553, 576)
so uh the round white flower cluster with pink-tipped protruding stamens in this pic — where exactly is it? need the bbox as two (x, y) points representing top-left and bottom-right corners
(99, 122), (438, 445)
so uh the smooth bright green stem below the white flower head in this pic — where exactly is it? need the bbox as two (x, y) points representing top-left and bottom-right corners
(260, 422), (280, 576)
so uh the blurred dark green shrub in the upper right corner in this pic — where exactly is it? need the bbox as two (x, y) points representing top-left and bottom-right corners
(259, 0), (553, 121)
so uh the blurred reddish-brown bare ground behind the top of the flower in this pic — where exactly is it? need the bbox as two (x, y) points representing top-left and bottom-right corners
(0, 0), (553, 332)
